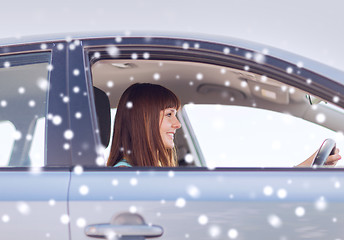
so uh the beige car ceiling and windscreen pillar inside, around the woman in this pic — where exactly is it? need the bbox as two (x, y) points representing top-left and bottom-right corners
(91, 59), (344, 166)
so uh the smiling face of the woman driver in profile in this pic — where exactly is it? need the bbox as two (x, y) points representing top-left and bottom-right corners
(159, 108), (181, 148)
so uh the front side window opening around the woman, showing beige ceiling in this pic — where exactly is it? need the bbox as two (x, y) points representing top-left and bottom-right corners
(89, 53), (344, 167)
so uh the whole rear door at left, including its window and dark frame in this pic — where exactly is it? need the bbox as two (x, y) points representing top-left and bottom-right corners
(0, 42), (70, 239)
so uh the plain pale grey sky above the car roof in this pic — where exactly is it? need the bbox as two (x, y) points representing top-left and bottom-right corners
(0, 0), (344, 71)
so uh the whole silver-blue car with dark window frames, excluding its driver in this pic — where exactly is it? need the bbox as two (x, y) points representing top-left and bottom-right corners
(0, 33), (344, 240)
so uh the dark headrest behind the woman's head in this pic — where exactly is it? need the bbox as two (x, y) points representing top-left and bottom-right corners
(93, 87), (111, 148)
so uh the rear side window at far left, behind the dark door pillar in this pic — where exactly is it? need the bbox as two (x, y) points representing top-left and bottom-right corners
(0, 52), (51, 167)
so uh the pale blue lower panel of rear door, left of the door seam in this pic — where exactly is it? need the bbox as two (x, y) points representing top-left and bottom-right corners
(0, 168), (70, 239)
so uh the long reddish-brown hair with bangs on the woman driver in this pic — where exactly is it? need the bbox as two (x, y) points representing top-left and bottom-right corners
(107, 83), (180, 167)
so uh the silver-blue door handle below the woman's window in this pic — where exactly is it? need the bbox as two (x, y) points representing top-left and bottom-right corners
(85, 213), (164, 239)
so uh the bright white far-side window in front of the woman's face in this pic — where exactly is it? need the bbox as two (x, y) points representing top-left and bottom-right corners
(184, 104), (343, 167)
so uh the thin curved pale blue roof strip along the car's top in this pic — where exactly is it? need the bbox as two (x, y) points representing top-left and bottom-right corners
(0, 31), (344, 84)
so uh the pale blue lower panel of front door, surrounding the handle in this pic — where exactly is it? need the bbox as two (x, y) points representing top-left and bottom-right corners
(69, 168), (344, 239)
